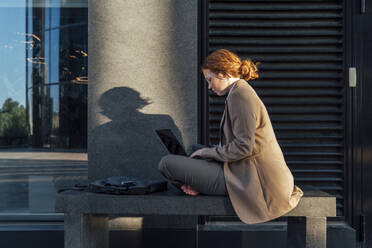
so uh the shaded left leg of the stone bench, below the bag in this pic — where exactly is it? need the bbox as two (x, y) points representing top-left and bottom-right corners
(64, 214), (109, 248)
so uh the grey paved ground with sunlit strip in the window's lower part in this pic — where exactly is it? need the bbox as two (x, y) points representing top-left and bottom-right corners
(0, 149), (88, 213)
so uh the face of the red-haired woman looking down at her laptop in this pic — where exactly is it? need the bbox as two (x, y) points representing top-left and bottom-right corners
(203, 69), (231, 96)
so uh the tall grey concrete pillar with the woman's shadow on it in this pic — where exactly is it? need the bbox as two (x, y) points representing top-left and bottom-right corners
(88, 0), (198, 180)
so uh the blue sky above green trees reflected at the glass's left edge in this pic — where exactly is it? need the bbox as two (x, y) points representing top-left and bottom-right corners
(0, 8), (28, 142)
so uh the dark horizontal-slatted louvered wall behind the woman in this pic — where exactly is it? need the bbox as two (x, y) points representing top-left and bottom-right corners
(205, 0), (345, 216)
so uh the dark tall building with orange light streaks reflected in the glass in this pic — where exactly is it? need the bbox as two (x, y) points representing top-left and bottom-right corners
(25, 1), (88, 148)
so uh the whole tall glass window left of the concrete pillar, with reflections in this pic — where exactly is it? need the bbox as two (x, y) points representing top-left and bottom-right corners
(0, 0), (88, 213)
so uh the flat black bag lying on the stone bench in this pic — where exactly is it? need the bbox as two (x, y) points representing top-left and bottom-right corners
(58, 176), (168, 195)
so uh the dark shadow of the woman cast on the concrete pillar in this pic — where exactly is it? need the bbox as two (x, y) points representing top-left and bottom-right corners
(88, 87), (182, 180)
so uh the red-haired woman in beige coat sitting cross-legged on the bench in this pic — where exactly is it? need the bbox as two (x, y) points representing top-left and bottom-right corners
(159, 49), (303, 224)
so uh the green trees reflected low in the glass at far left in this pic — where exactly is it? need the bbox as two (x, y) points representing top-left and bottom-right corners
(0, 98), (28, 138)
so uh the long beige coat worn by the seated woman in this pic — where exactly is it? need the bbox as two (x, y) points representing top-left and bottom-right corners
(201, 79), (303, 224)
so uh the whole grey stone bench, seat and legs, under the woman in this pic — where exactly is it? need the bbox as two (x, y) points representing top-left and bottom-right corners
(55, 188), (336, 248)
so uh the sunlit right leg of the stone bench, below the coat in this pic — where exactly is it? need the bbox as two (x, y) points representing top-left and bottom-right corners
(287, 217), (327, 248)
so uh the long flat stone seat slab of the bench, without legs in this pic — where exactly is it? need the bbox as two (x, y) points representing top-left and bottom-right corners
(55, 190), (336, 216)
